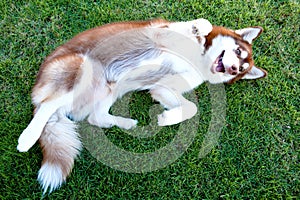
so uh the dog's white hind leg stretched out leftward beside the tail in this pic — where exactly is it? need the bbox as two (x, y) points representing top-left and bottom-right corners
(17, 92), (73, 152)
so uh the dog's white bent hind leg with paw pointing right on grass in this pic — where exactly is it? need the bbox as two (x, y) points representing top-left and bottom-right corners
(88, 95), (137, 129)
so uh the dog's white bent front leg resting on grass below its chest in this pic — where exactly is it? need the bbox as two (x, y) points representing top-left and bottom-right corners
(150, 87), (197, 126)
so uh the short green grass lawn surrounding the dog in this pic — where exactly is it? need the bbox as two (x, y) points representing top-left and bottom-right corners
(0, 0), (300, 199)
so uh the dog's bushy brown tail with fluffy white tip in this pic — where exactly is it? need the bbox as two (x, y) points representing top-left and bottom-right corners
(38, 111), (81, 194)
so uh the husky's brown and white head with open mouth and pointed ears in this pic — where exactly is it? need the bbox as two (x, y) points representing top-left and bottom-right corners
(204, 26), (267, 83)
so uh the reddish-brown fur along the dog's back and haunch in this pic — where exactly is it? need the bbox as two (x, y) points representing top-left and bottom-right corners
(32, 19), (170, 106)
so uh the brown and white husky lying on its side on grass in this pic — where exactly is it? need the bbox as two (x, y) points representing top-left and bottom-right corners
(17, 19), (267, 193)
